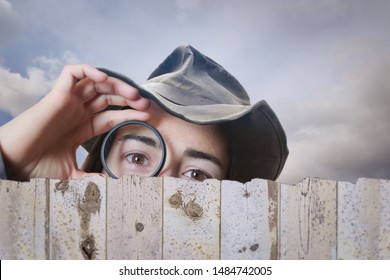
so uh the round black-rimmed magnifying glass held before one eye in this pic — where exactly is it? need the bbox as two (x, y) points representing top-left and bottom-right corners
(100, 120), (166, 178)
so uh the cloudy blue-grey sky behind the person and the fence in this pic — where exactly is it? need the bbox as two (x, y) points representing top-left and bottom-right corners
(0, 0), (390, 184)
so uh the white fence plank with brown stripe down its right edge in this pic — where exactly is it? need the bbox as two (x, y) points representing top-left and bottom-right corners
(221, 179), (279, 260)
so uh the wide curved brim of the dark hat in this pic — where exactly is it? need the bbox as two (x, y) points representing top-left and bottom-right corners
(83, 68), (288, 182)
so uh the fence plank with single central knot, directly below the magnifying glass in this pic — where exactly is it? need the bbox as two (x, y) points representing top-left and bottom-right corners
(107, 176), (162, 259)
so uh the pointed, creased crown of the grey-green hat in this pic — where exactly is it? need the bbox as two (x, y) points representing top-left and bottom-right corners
(142, 46), (250, 106)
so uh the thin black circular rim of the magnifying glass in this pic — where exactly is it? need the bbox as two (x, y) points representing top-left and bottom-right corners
(100, 120), (166, 179)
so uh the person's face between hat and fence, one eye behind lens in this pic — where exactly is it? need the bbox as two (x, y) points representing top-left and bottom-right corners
(106, 102), (230, 181)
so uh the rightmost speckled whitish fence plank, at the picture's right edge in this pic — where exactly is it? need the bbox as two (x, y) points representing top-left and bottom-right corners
(338, 178), (390, 259)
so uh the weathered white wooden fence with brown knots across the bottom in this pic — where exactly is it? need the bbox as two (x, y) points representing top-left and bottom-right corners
(0, 176), (390, 259)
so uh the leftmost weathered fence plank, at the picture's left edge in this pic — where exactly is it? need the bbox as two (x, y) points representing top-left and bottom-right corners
(0, 179), (47, 259)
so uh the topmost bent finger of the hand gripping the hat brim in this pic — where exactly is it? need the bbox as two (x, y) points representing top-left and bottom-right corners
(54, 64), (107, 92)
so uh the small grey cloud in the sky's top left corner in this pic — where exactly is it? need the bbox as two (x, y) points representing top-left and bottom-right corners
(0, 0), (23, 47)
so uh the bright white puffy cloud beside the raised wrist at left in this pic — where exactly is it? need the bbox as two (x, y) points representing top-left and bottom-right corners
(0, 52), (77, 116)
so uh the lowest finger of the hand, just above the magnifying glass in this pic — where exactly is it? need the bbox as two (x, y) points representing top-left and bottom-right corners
(87, 109), (150, 139)
